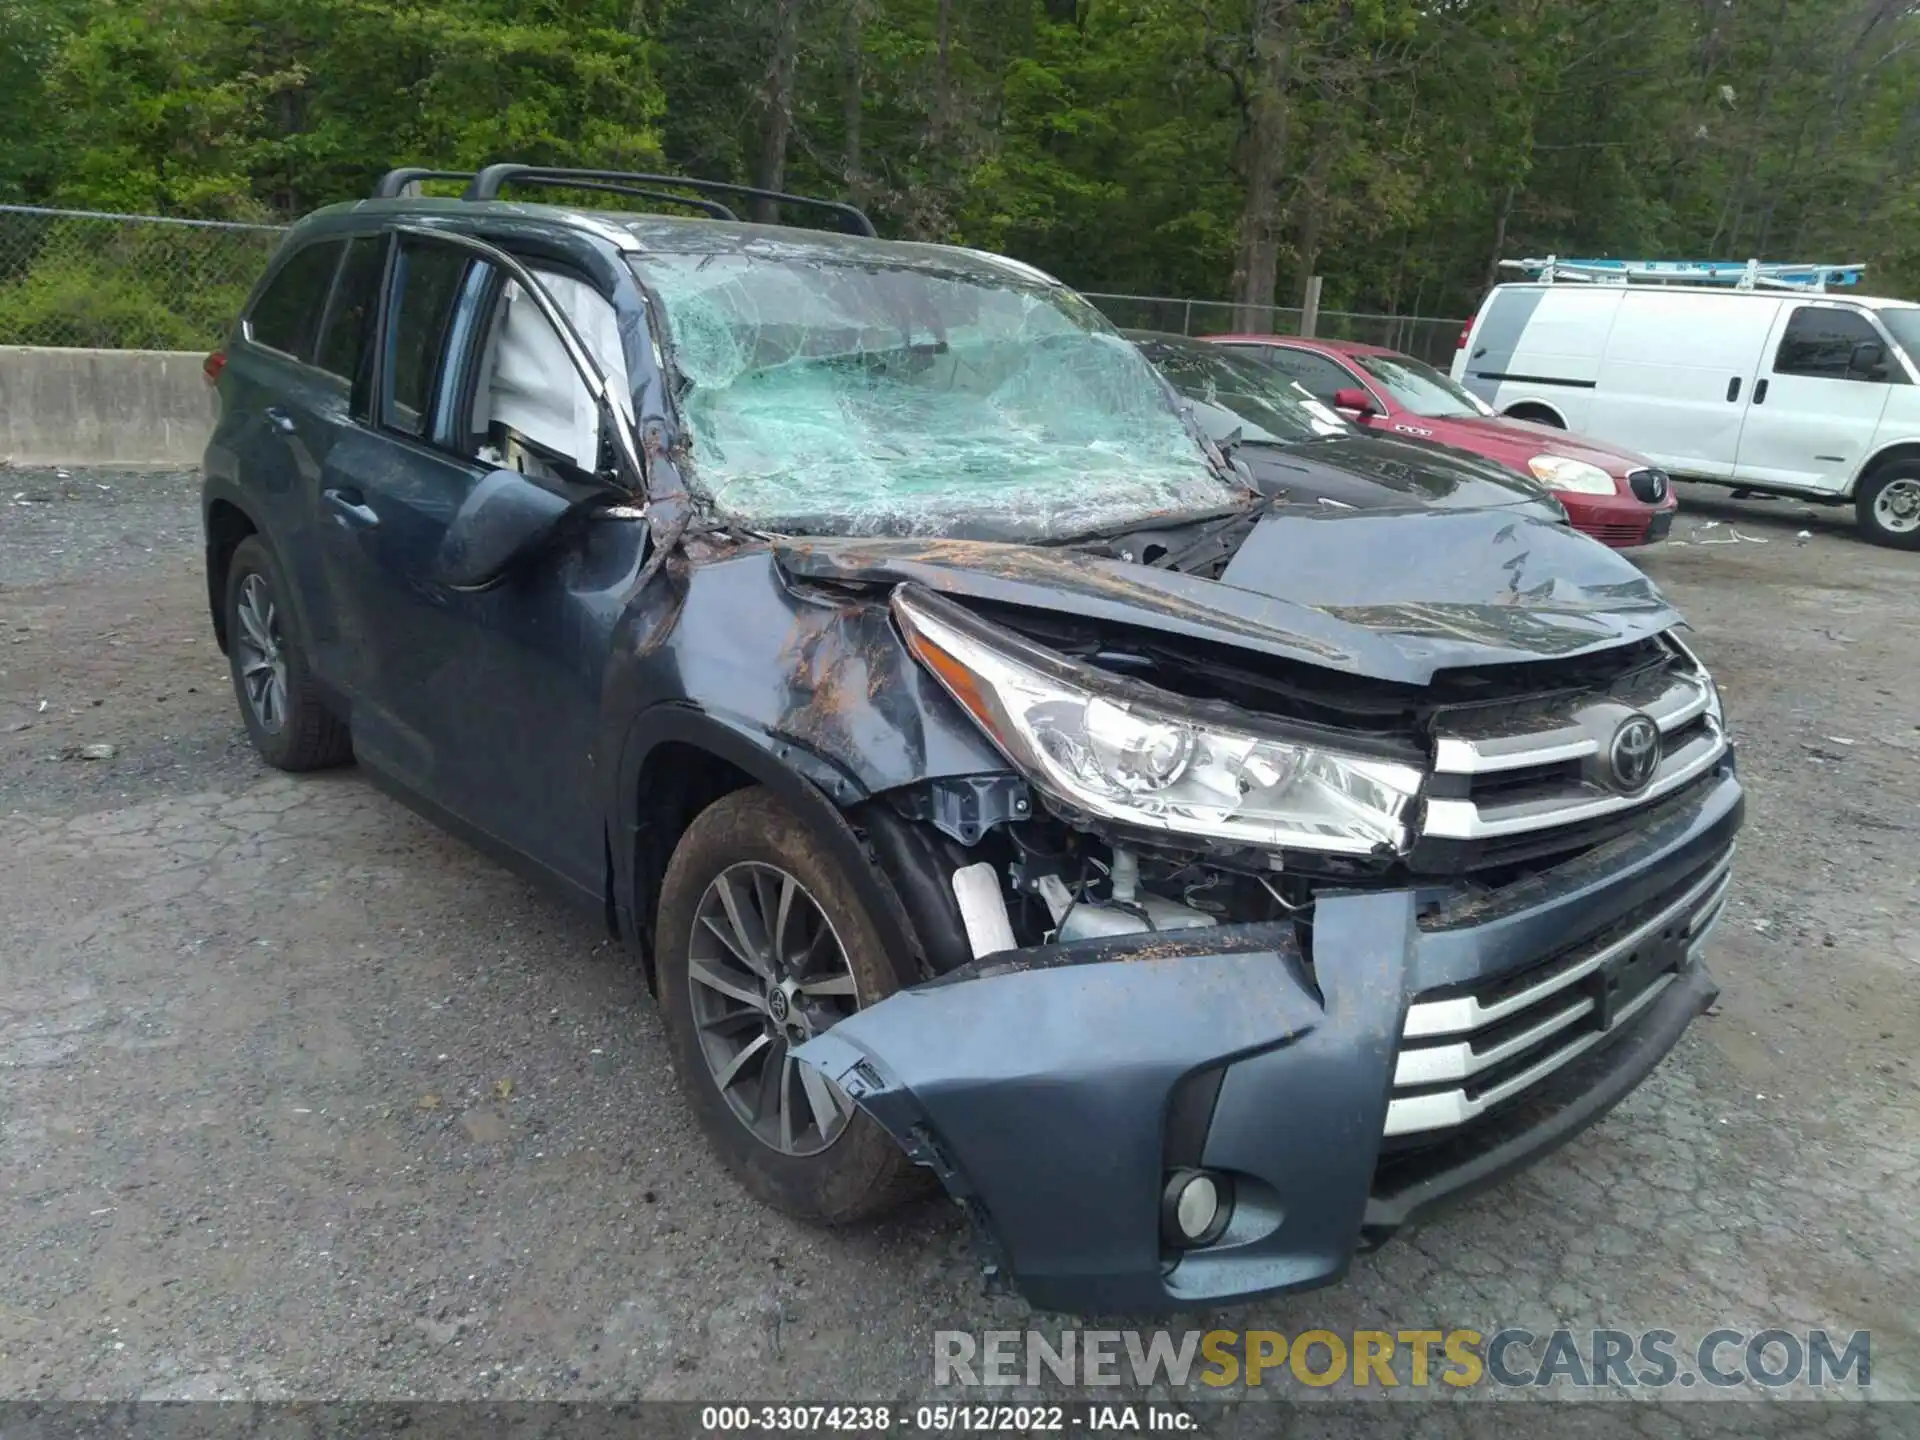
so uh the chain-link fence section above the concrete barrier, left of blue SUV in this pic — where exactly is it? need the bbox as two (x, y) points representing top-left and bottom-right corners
(0, 205), (282, 349)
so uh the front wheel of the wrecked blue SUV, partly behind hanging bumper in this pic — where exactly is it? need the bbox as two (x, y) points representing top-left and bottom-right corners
(655, 787), (929, 1225)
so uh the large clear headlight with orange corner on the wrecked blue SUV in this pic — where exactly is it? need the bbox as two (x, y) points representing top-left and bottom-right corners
(893, 586), (1421, 854)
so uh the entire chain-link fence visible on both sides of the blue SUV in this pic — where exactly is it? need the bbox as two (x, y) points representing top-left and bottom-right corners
(0, 205), (1461, 369)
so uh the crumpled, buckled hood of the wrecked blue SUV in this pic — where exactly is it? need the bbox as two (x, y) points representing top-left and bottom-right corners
(776, 509), (1680, 685)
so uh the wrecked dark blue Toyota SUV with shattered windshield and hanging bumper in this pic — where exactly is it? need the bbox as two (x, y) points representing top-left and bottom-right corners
(205, 165), (1741, 1313)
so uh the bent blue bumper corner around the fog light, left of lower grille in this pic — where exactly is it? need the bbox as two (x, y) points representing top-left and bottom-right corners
(795, 891), (1413, 1313)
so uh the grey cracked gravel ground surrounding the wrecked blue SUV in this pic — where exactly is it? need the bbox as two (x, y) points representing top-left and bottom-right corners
(0, 470), (1920, 1432)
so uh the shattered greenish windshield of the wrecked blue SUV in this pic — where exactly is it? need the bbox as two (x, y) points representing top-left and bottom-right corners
(634, 250), (1250, 540)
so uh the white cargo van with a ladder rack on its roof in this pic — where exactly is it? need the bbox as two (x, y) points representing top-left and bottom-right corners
(1453, 261), (1920, 549)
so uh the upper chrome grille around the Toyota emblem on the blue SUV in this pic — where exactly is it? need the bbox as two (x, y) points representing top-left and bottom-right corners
(1415, 645), (1726, 849)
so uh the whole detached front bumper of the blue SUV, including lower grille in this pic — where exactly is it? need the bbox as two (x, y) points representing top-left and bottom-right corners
(795, 766), (1743, 1313)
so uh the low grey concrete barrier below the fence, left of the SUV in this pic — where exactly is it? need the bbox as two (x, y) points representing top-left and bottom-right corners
(0, 346), (215, 468)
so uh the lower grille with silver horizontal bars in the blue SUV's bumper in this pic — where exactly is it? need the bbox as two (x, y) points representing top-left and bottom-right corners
(1386, 847), (1734, 1139)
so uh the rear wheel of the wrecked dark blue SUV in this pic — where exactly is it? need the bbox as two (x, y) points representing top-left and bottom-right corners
(227, 536), (353, 770)
